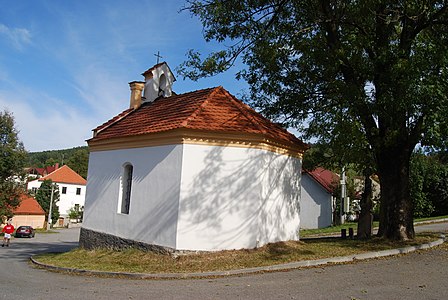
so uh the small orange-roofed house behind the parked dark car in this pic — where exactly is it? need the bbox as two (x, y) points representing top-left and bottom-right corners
(12, 194), (45, 228)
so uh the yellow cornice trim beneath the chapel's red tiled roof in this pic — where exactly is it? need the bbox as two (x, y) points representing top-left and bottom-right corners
(87, 129), (306, 158)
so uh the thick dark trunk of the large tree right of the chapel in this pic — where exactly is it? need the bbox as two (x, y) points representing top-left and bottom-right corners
(376, 146), (415, 240)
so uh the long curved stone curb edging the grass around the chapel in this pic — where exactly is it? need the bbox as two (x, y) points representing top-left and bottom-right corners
(30, 235), (446, 279)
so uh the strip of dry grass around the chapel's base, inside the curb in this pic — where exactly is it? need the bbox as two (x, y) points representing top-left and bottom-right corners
(34, 233), (448, 274)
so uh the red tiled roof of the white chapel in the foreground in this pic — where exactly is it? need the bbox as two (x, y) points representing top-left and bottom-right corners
(89, 87), (307, 149)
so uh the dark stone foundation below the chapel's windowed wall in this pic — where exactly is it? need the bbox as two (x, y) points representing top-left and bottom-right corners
(79, 228), (175, 254)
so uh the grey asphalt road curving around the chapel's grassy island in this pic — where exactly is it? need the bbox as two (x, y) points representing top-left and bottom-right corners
(0, 223), (448, 300)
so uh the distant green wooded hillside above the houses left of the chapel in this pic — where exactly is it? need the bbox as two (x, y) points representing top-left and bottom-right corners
(26, 146), (89, 178)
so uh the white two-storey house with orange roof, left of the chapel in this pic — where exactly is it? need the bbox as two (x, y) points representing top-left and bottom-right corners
(27, 165), (87, 226)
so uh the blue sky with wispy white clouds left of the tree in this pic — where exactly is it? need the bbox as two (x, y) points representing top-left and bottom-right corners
(0, 0), (247, 152)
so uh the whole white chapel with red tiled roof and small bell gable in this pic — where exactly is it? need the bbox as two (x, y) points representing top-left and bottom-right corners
(80, 63), (307, 252)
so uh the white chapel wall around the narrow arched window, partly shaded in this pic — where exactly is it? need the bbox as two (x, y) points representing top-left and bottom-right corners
(83, 145), (182, 248)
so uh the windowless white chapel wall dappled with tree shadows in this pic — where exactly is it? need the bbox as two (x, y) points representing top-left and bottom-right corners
(177, 145), (301, 250)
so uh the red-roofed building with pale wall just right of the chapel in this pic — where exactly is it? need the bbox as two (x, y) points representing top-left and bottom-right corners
(300, 168), (339, 229)
